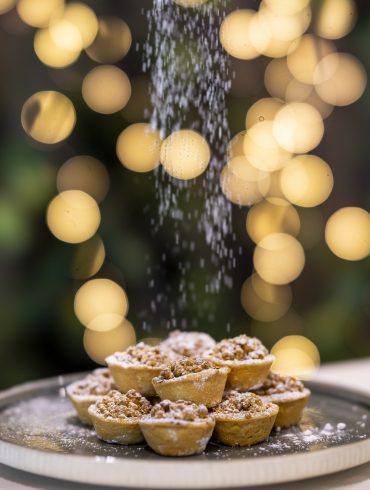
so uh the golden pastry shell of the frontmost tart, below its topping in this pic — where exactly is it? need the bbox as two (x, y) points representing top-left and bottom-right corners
(140, 417), (215, 456)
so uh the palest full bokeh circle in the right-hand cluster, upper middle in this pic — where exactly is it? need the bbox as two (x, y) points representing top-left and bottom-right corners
(273, 102), (324, 153)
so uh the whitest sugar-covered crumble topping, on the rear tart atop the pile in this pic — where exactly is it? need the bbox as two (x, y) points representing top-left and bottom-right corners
(162, 330), (216, 357)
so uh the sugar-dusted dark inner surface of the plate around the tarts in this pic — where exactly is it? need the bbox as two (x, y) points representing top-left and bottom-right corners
(0, 380), (370, 461)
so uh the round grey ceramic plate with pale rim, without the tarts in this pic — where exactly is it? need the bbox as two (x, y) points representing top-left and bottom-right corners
(0, 374), (370, 488)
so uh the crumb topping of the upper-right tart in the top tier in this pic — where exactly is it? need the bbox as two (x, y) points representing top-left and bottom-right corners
(207, 335), (268, 361)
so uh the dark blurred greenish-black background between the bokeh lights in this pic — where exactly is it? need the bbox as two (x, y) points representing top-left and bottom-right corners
(0, 0), (370, 387)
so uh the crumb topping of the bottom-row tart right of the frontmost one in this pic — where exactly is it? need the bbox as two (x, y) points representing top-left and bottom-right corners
(212, 391), (271, 417)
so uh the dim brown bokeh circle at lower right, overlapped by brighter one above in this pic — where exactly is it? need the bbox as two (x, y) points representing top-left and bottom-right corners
(241, 274), (292, 322)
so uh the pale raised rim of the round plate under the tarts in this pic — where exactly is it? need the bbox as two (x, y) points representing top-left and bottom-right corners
(0, 372), (370, 489)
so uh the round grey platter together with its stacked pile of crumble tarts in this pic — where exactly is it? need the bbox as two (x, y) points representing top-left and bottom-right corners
(0, 331), (370, 488)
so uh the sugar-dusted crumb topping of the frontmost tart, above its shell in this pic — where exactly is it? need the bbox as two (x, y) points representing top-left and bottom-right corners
(150, 400), (209, 422)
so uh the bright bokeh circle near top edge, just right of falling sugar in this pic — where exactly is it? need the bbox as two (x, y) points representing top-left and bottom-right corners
(220, 9), (259, 60)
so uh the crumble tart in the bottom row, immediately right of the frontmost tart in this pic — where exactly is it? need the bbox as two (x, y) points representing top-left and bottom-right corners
(212, 392), (279, 446)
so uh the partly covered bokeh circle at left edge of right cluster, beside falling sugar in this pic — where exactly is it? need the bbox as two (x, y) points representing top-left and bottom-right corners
(220, 156), (270, 206)
